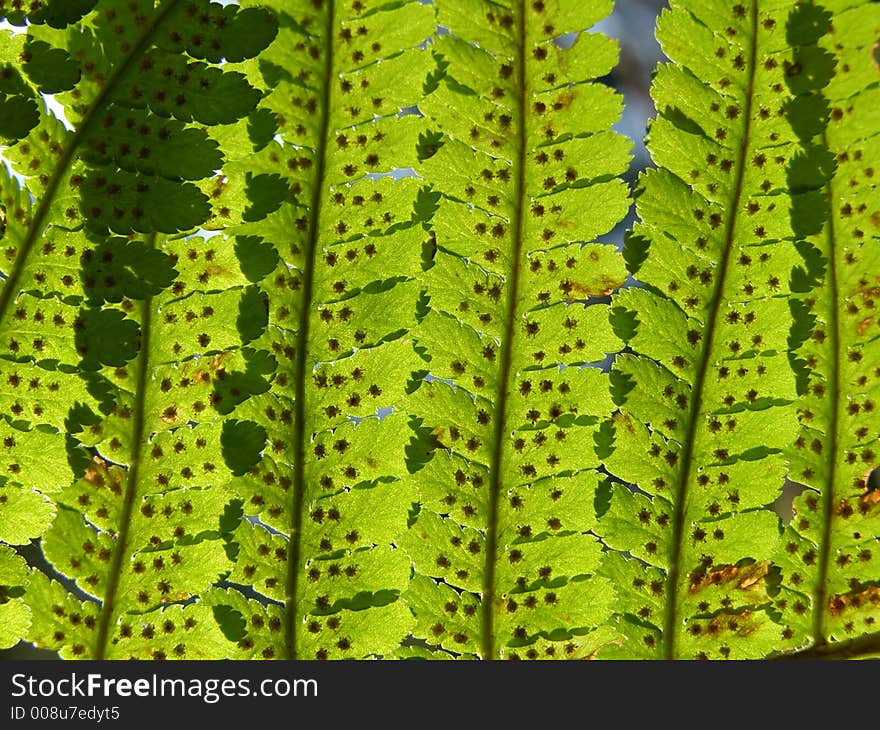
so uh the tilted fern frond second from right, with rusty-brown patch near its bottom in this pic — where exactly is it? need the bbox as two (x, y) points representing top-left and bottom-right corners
(600, 0), (824, 659)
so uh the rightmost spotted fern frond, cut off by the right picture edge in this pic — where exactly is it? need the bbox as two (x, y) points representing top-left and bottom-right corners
(776, 2), (880, 656)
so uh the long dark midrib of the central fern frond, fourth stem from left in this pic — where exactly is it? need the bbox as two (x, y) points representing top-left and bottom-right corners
(480, 0), (528, 659)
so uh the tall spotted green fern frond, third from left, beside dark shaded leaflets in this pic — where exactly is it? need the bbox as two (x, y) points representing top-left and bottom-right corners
(205, 2), (433, 659)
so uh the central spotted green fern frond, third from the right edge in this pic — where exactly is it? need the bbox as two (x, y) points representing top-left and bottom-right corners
(401, 0), (628, 659)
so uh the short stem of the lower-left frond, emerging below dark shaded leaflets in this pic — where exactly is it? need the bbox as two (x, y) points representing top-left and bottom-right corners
(95, 233), (156, 659)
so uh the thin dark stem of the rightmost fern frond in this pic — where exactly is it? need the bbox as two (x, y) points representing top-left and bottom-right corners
(812, 132), (843, 646)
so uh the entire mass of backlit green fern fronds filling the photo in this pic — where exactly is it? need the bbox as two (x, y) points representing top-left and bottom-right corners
(0, 0), (880, 659)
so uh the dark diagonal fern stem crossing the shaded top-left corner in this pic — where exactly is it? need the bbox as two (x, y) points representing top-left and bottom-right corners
(0, 0), (178, 323)
